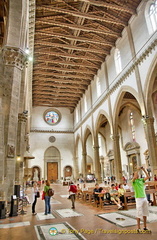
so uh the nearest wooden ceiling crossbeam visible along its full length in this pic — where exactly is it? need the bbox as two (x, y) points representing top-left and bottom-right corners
(36, 5), (126, 27)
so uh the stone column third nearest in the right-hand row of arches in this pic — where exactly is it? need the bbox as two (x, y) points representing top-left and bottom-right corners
(93, 146), (101, 182)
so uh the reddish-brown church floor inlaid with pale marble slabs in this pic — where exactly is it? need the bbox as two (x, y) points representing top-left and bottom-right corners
(0, 184), (157, 240)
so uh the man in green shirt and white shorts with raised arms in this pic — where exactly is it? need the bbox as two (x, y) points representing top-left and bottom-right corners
(132, 167), (149, 232)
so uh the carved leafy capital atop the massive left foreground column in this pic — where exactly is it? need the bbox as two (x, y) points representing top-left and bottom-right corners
(2, 46), (27, 70)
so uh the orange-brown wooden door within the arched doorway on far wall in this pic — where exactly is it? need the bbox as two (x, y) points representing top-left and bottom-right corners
(47, 162), (58, 182)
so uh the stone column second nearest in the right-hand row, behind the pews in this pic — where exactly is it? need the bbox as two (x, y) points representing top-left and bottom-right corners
(113, 134), (122, 183)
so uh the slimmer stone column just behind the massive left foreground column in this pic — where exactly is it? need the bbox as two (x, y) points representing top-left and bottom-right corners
(15, 113), (27, 184)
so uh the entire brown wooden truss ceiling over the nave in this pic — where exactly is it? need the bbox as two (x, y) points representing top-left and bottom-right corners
(33, 0), (141, 112)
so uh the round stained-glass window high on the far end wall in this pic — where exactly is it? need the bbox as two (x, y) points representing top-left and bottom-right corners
(44, 109), (61, 125)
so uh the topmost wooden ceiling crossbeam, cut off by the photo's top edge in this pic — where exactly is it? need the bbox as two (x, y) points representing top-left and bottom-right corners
(79, 0), (136, 15)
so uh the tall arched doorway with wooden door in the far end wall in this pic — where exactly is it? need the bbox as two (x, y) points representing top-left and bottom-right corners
(44, 147), (61, 182)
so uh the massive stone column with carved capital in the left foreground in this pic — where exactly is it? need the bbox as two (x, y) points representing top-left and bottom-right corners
(2, 47), (26, 200)
